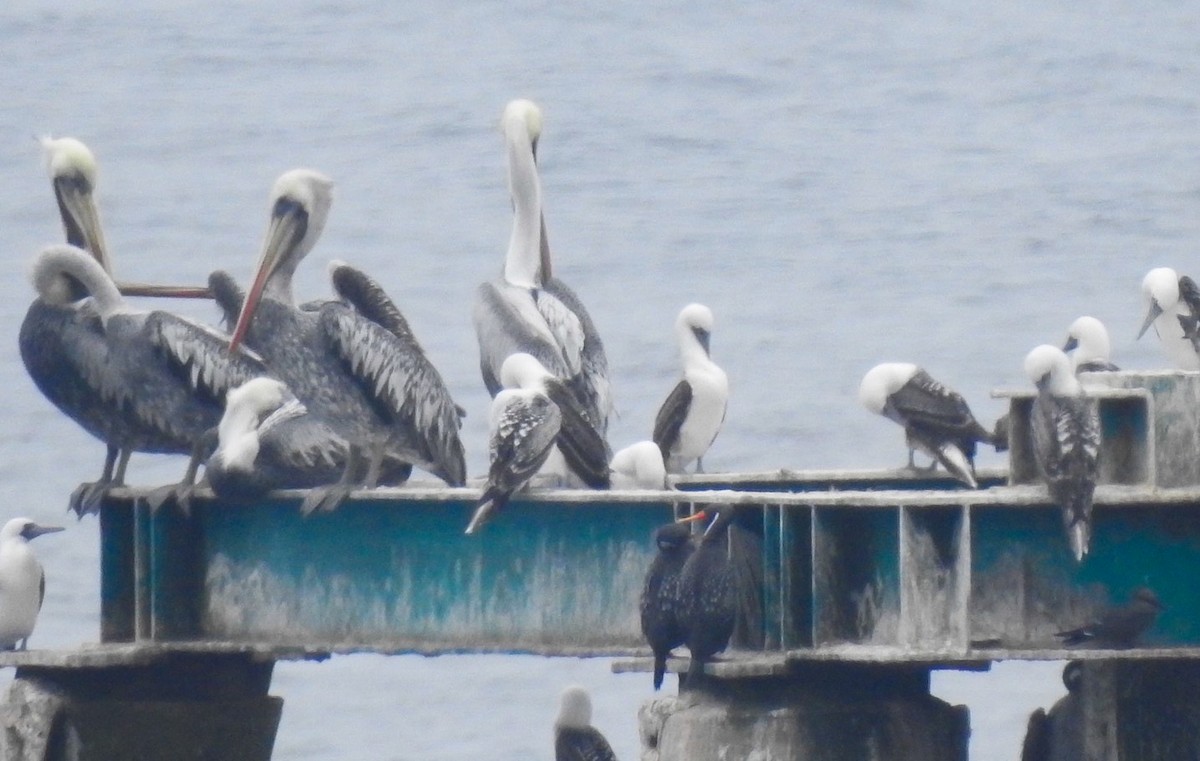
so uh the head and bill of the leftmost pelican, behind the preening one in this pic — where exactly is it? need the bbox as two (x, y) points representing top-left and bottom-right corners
(38, 137), (113, 272)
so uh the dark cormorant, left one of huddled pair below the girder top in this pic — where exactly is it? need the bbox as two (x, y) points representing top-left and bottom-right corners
(638, 522), (695, 689)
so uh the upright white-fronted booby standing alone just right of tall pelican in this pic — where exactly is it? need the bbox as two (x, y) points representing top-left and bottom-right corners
(653, 304), (730, 473)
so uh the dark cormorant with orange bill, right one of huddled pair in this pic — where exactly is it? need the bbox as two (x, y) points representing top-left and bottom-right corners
(679, 505), (738, 681)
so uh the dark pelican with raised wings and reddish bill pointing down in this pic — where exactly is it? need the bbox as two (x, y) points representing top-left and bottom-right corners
(232, 169), (467, 513)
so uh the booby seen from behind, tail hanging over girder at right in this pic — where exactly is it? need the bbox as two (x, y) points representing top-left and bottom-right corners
(1025, 344), (1100, 561)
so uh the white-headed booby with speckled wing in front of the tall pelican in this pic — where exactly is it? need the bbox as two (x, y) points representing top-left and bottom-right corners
(467, 353), (610, 534)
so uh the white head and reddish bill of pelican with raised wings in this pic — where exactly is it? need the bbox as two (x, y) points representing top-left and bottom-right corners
(229, 169), (334, 352)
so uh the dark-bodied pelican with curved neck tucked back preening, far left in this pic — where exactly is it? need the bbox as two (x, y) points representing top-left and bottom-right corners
(32, 245), (265, 514)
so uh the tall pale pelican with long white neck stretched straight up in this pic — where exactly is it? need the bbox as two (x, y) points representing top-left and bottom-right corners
(472, 100), (612, 436)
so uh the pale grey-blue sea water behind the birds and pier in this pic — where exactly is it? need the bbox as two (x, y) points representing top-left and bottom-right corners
(0, 0), (1200, 761)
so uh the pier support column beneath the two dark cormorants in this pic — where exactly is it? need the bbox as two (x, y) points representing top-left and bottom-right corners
(638, 664), (971, 761)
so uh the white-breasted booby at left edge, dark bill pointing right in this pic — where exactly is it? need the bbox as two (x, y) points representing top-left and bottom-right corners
(0, 517), (62, 651)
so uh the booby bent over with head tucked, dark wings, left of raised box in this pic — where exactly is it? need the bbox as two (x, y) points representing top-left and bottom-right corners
(858, 362), (1007, 489)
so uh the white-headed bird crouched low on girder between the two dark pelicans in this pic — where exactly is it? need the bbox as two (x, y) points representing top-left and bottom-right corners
(204, 376), (413, 499)
